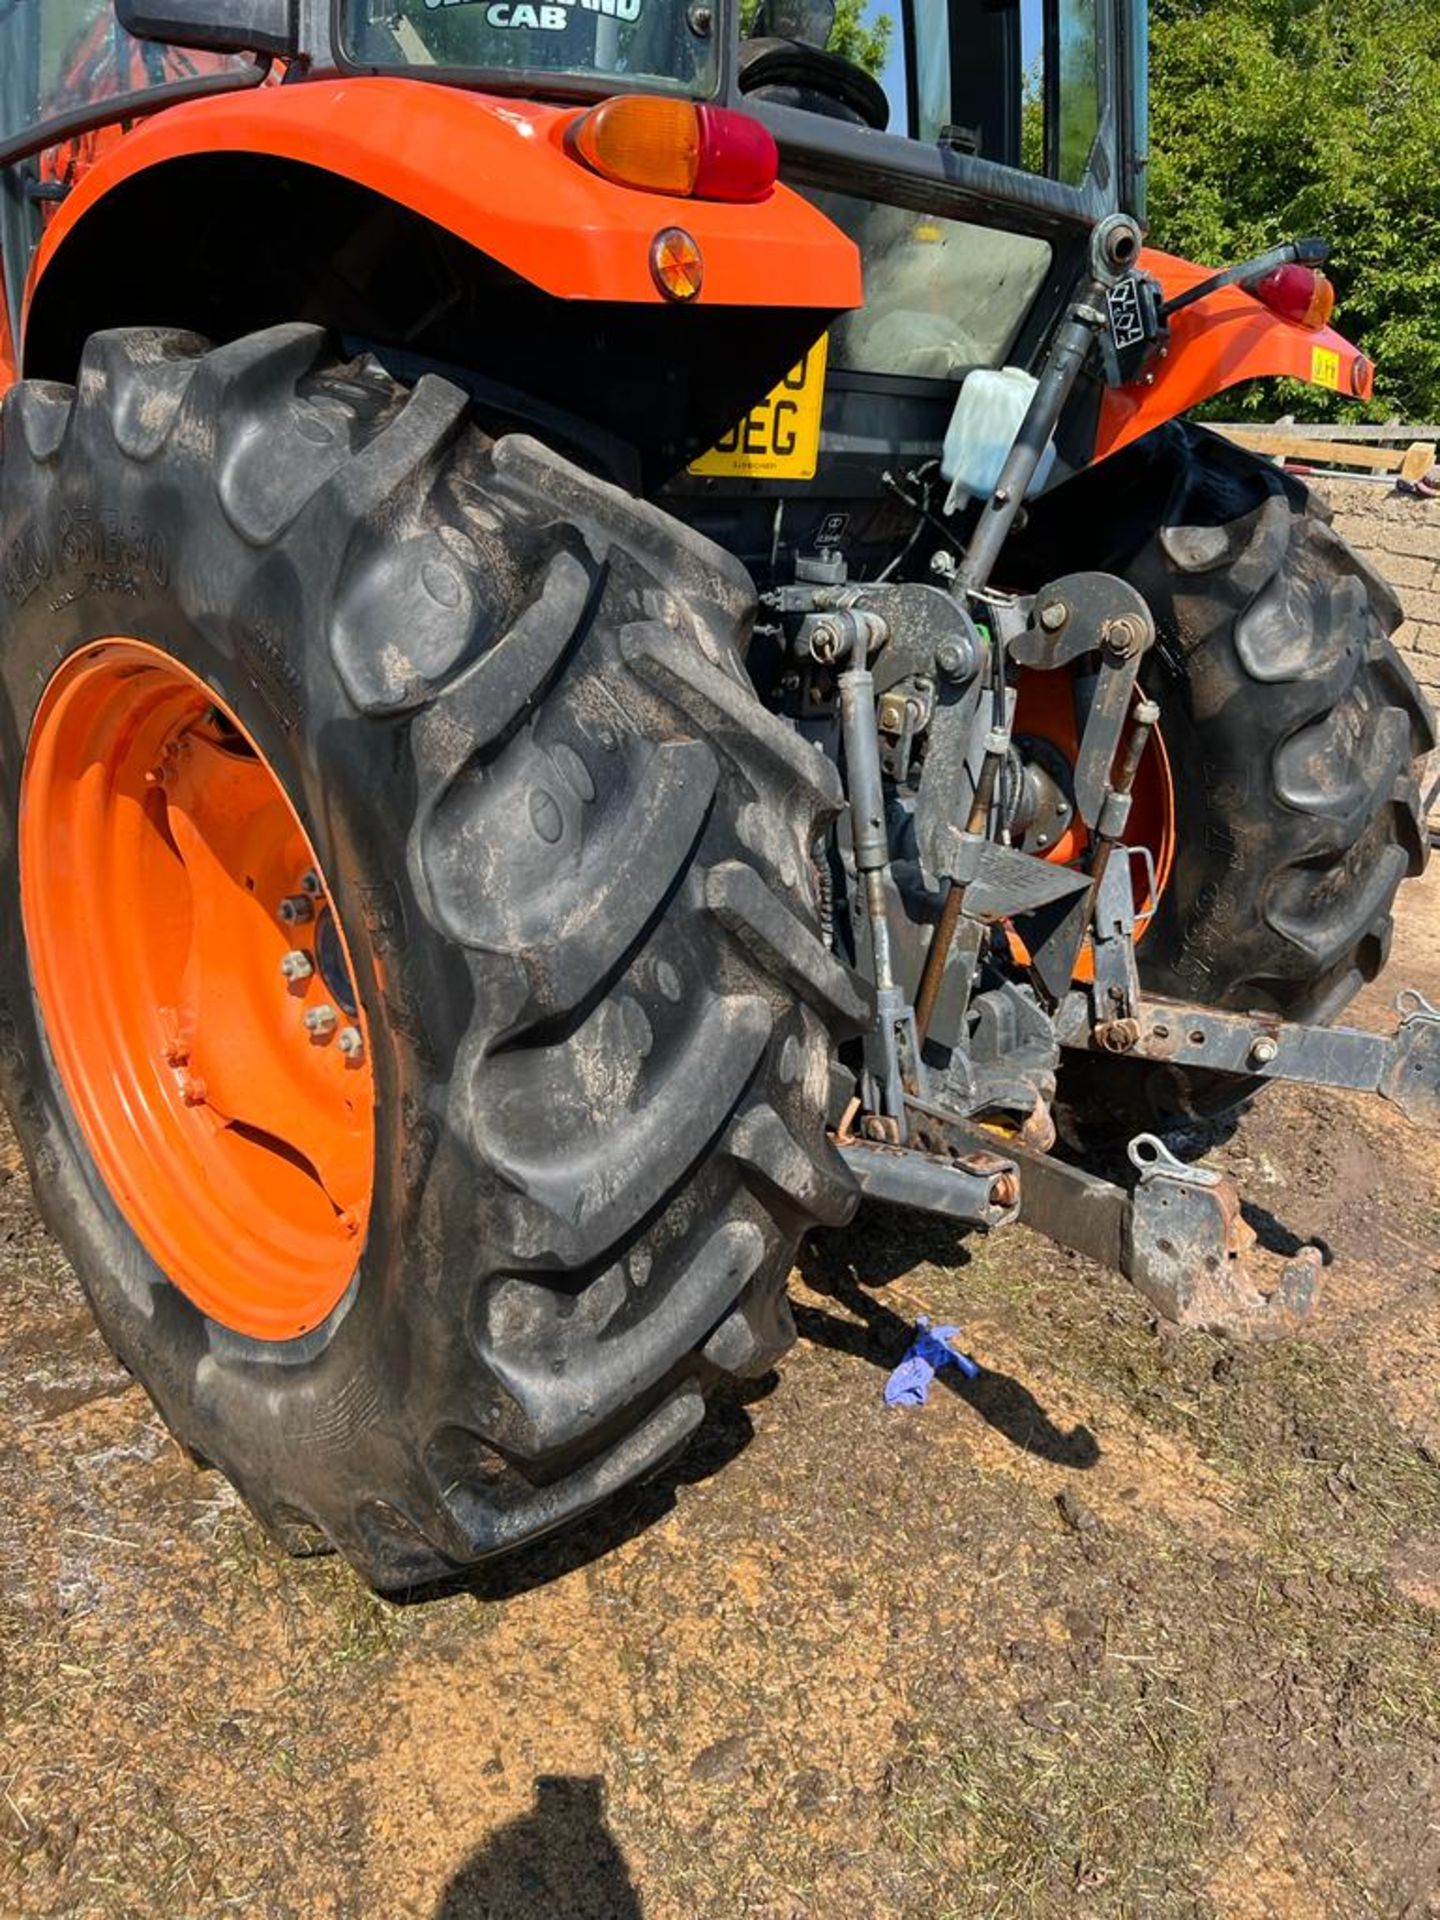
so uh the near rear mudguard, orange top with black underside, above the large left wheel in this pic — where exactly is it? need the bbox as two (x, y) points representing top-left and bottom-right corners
(23, 79), (862, 492)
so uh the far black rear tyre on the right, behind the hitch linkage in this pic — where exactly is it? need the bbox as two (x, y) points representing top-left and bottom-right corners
(1023, 422), (1434, 1144)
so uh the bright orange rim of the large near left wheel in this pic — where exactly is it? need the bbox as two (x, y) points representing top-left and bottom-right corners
(19, 639), (374, 1340)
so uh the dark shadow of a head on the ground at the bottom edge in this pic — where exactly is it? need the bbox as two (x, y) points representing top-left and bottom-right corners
(434, 1774), (643, 1920)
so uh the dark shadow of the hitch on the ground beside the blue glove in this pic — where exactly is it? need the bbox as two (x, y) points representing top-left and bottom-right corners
(795, 1208), (1100, 1473)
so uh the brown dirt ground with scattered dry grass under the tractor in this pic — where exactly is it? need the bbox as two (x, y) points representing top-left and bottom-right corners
(0, 862), (1440, 1920)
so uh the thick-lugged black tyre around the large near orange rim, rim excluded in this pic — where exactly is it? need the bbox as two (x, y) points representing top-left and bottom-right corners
(0, 324), (866, 1592)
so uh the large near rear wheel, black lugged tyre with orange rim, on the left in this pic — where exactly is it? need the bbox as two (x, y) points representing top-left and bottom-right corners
(0, 324), (864, 1590)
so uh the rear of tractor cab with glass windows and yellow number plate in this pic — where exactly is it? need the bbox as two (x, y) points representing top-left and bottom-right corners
(338, 0), (1144, 582)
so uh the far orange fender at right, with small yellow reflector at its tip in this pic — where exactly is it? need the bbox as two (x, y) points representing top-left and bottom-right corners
(1094, 248), (1375, 461)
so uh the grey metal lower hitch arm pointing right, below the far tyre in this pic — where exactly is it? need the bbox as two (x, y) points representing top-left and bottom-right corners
(1056, 987), (1440, 1123)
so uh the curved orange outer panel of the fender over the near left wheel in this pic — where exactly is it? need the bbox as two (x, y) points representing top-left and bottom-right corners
(27, 79), (862, 339)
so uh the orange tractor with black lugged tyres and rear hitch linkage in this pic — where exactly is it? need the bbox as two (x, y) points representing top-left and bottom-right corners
(0, 0), (1440, 1590)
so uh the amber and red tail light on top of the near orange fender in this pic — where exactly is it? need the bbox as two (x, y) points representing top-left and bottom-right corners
(568, 94), (780, 200)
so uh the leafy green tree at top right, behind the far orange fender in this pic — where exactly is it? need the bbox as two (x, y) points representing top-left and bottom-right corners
(1150, 0), (1440, 420)
